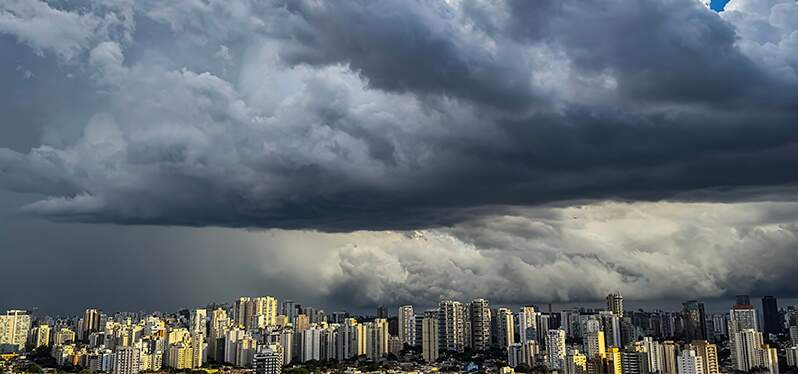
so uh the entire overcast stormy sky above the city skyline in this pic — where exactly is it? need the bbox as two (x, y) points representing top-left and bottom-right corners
(0, 0), (798, 313)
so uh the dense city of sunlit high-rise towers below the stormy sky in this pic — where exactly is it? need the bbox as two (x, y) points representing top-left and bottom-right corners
(0, 293), (798, 374)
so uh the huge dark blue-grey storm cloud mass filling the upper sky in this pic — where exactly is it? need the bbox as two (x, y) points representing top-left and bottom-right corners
(0, 0), (798, 231)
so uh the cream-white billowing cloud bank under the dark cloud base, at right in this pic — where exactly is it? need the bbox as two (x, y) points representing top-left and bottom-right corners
(284, 202), (798, 305)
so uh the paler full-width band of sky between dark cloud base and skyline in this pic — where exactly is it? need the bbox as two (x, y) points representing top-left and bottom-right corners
(0, 202), (798, 312)
